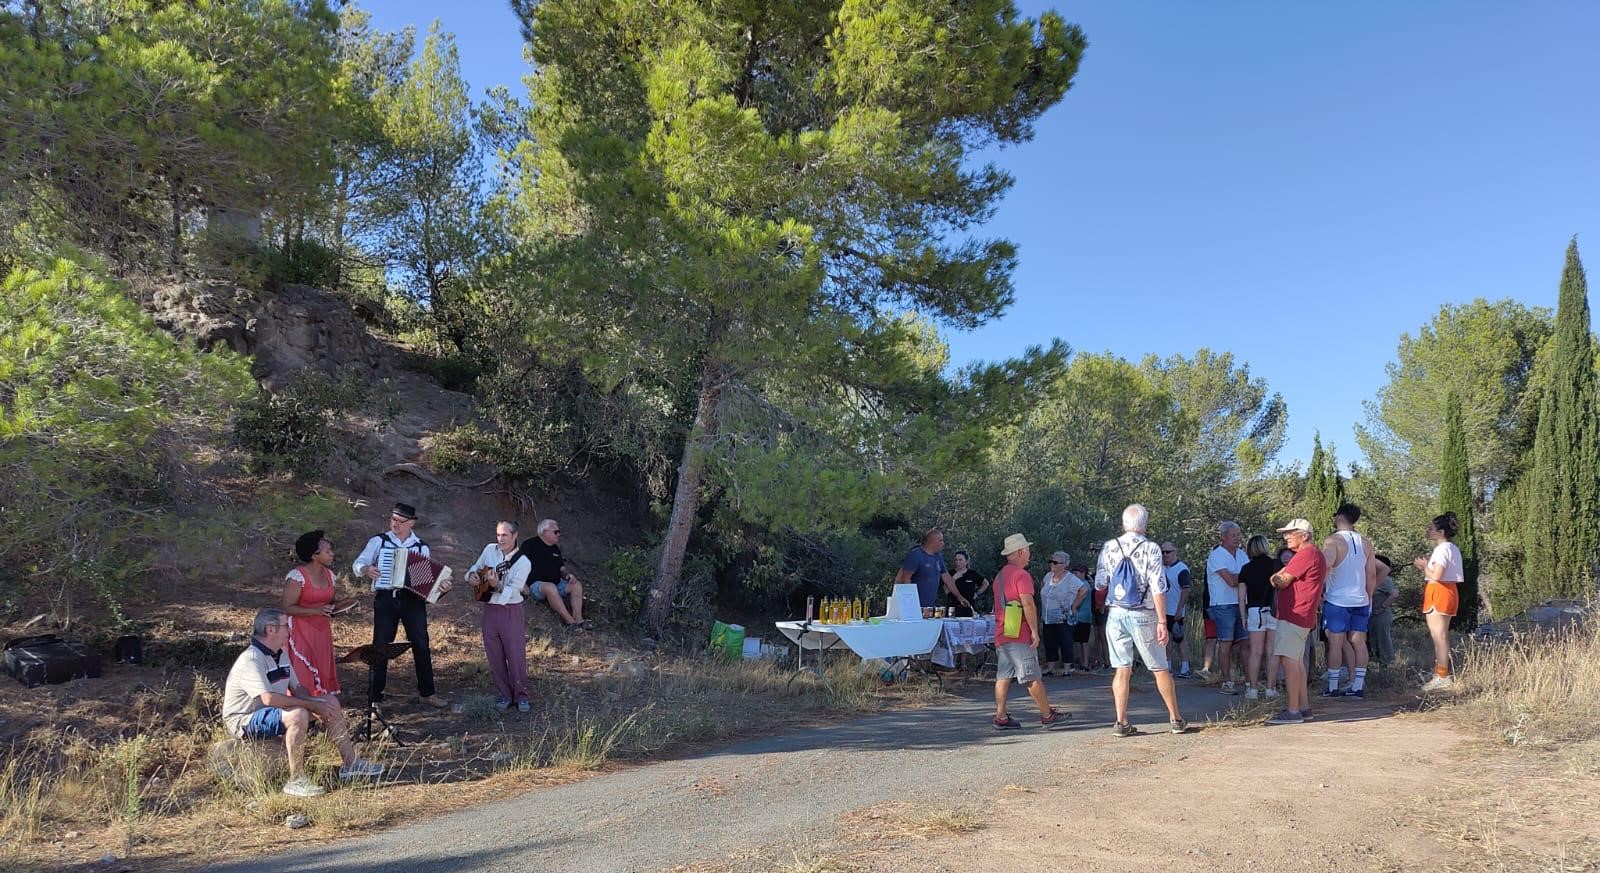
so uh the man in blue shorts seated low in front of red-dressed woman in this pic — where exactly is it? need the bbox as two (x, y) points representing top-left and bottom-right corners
(222, 609), (384, 798)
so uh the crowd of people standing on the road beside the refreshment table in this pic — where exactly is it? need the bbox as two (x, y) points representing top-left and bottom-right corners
(896, 502), (1462, 735)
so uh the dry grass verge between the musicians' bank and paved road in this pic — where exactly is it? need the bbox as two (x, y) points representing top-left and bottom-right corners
(0, 644), (942, 873)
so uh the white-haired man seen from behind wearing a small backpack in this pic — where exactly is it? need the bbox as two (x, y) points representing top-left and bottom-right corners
(1094, 504), (1189, 737)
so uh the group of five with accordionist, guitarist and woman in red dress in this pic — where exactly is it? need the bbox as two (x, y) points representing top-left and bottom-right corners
(222, 502), (592, 796)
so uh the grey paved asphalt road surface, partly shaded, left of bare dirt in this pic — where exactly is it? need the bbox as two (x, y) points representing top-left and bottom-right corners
(208, 678), (1234, 873)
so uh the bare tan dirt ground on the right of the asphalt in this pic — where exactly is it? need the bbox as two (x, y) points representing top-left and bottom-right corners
(672, 710), (1600, 873)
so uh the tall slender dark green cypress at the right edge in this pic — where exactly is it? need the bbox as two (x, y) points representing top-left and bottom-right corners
(1523, 240), (1600, 598)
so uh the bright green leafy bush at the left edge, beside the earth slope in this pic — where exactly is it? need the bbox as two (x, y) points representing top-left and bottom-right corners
(0, 259), (253, 620)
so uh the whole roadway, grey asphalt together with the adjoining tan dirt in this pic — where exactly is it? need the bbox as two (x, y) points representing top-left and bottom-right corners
(184, 678), (1454, 873)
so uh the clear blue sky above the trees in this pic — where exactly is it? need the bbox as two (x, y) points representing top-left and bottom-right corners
(366, 0), (1600, 460)
